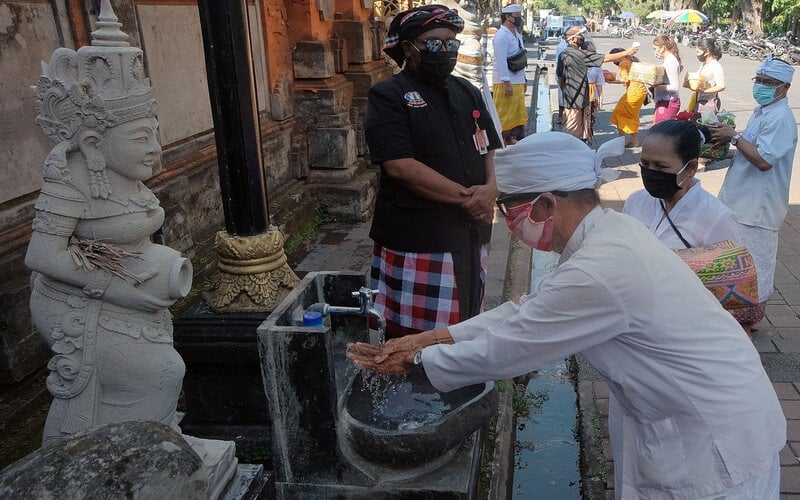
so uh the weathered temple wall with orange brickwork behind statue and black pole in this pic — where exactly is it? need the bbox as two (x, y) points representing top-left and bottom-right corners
(0, 0), (391, 390)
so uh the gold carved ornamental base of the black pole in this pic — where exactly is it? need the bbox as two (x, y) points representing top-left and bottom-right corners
(205, 228), (300, 312)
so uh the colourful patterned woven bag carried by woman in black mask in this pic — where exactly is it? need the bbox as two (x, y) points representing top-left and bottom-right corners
(675, 240), (759, 322)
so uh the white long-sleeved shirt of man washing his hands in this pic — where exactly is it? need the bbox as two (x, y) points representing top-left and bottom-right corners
(422, 207), (786, 499)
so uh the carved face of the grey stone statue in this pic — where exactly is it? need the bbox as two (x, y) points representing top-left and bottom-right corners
(98, 118), (161, 181)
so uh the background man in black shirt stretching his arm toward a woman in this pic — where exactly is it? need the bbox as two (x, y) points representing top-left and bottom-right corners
(556, 26), (639, 140)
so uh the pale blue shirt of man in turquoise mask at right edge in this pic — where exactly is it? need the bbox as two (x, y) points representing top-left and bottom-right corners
(719, 97), (797, 231)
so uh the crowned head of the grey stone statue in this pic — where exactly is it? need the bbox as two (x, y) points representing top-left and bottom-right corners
(32, 0), (161, 198)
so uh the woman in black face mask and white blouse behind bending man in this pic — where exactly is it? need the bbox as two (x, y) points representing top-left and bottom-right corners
(622, 120), (739, 249)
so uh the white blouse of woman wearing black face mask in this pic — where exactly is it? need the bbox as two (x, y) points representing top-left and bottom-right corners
(622, 179), (742, 248)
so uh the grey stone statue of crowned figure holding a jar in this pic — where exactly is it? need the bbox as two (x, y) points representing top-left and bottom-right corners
(25, 0), (236, 498)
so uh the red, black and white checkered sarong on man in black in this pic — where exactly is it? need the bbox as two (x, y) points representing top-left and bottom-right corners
(372, 245), (489, 331)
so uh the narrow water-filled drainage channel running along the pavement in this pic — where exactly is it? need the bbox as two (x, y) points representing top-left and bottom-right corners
(512, 67), (580, 500)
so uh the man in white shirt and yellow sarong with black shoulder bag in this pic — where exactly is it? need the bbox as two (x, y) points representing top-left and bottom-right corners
(492, 3), (528, 144)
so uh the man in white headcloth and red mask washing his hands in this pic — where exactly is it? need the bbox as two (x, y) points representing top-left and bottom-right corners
(348, 132), (786, 499)
